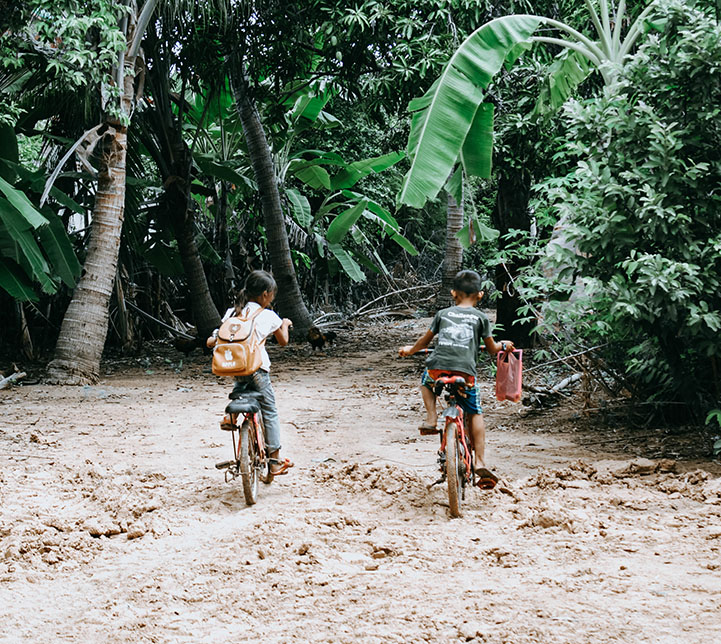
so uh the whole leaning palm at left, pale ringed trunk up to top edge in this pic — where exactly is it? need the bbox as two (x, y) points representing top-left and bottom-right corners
(48, 0), (158, 384)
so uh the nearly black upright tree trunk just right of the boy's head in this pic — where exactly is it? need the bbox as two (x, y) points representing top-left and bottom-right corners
(493, 172), (535, 347)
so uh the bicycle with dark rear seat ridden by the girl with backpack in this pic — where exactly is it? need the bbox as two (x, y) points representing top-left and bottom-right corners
(215, 391), (273, 505)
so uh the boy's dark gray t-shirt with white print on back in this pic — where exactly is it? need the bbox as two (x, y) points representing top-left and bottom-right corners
(426, 306), (491, 376)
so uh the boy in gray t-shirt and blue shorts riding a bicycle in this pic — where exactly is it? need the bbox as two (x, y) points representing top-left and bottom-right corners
(398, 270), (515, 489)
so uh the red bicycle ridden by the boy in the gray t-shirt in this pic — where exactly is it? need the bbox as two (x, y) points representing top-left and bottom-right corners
(431, 374), (475, 518)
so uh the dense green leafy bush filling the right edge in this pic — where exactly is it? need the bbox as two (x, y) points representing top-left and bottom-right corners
(529, 0), (721, 418)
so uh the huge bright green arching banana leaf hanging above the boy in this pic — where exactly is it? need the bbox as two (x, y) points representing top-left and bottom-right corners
(398, 15), (542, 208)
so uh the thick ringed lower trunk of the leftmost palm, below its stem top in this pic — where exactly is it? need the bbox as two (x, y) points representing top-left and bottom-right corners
(48, 125), (128, 385)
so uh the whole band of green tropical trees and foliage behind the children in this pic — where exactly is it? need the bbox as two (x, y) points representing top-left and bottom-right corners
(0, 0), (721, 422)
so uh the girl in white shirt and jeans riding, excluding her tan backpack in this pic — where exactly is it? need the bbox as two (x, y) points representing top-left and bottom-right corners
(206, 270), (293, 476)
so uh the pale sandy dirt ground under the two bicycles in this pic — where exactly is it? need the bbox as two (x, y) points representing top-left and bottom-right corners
(0, 321), (721, 644)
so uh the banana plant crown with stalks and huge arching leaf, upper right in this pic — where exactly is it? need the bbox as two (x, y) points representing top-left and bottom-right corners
(398, 0), (655, 208)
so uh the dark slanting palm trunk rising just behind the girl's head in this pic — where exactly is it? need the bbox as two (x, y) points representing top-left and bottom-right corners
(233, 70), (312, 335)
